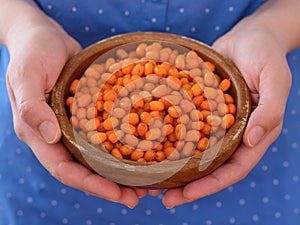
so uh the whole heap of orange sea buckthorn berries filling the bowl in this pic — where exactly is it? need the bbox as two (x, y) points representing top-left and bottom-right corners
(65, 42), (237, 163)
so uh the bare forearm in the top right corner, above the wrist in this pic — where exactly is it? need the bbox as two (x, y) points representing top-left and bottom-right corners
(248, 0), (300, 52)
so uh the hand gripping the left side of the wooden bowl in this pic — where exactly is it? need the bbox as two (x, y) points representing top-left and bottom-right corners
(6, 0), (146, 208)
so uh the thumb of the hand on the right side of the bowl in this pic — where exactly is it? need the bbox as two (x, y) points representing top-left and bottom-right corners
(243, 60), (291, 147)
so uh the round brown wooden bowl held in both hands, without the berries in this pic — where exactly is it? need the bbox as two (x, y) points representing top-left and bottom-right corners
(51, 32), (251, 188)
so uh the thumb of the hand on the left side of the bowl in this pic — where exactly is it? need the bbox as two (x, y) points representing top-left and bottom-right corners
(7, 64), (61, 144)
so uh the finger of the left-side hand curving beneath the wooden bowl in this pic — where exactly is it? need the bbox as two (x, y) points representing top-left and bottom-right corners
(29, 130), (121, 202)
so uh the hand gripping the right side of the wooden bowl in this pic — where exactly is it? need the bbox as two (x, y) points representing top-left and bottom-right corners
(163, 19), (291, 207)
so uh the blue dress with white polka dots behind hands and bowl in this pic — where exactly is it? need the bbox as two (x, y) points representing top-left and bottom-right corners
(0, 0), (300, 225)
